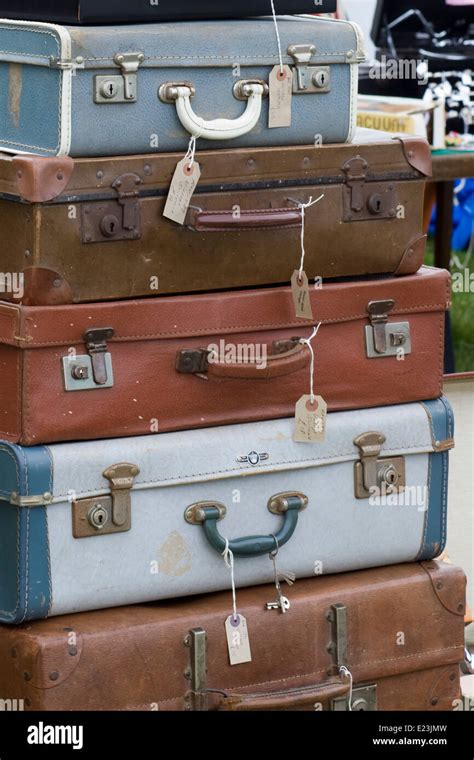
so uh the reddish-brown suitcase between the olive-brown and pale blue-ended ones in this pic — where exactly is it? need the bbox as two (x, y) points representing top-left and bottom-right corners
(0, 267), (450, 445)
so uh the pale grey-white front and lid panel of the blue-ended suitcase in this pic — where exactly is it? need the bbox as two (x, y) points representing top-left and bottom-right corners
(25, 404), (446, 615)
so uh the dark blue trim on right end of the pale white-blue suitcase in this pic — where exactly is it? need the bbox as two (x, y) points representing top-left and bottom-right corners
(417, 396), (454, 562)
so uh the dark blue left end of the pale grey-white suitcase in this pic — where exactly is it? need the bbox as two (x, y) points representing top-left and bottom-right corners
(0, 442), (53, 624)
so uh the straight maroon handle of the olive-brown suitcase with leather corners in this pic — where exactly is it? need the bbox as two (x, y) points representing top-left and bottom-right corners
(186, 207), (301, 232)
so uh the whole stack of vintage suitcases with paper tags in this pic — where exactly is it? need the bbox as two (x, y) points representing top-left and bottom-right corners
(0, 0), (465, 711)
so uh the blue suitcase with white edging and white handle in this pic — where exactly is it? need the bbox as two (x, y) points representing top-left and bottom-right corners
(0, 16), (365, 157)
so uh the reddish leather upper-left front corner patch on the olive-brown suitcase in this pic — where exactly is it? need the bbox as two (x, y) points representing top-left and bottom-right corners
(12, 156), (74, 203)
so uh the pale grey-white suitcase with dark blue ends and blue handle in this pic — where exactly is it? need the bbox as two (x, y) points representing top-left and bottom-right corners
(0, 398), (454, 623)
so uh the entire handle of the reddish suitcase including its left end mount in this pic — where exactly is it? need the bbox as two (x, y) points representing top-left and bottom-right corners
(176, 338), (311, 380)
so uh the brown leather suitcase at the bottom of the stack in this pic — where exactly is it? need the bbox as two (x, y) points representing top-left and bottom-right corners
(0, 562), (466, 711)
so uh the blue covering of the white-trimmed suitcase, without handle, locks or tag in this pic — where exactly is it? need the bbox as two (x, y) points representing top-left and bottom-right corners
(0, 17), (358, 157)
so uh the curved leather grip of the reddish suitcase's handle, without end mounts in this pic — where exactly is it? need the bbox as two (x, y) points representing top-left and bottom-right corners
(208, 343), (311, 380)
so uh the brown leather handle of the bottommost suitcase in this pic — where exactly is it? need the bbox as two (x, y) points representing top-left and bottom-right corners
(218, 680), (350, 712)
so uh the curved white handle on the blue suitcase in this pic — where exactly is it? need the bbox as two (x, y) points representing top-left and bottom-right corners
(171, 84), (265, 140)
